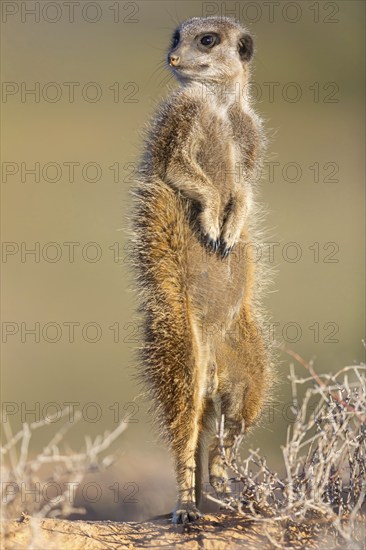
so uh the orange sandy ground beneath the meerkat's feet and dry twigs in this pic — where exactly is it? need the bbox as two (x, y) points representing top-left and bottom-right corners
(1, 513), (354, 550)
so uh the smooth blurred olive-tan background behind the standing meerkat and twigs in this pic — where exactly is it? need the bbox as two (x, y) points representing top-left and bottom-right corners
(1, 0), (365, 516)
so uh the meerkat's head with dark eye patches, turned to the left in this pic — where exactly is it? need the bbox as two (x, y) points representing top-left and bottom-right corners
(167, 17), (254, 83)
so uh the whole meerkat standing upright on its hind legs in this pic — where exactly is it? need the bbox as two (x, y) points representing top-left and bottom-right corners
(133, 17), (272, 523)
